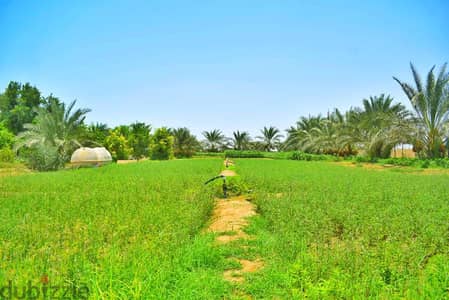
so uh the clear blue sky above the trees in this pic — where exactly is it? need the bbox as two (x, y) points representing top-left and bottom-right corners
(0, 0), (449, 135)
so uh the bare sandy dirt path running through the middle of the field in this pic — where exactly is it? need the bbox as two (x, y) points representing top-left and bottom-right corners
(207, 161), (263, 284)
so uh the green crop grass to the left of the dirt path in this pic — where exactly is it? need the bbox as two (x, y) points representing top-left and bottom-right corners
(0, 160), (229, 299)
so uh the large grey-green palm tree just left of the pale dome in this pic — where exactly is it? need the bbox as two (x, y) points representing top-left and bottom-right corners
(15, 101), (90, 161)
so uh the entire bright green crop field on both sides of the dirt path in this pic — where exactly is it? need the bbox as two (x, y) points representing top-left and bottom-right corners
(0, 158), (449, 299)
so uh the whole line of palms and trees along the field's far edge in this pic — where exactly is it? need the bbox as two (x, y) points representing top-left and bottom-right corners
(0, 64), (449, 170)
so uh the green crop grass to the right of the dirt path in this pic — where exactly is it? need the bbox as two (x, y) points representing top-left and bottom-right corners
(237, 160), (449, 299)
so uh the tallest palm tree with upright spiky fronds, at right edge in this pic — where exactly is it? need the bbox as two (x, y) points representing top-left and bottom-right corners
(393, 63), (449, 157)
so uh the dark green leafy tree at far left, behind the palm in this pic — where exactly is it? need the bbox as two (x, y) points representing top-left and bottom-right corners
(0, 81), (43, 135)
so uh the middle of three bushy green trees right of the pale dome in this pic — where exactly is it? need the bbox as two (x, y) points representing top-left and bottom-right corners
(129, 122), (151, 159)
